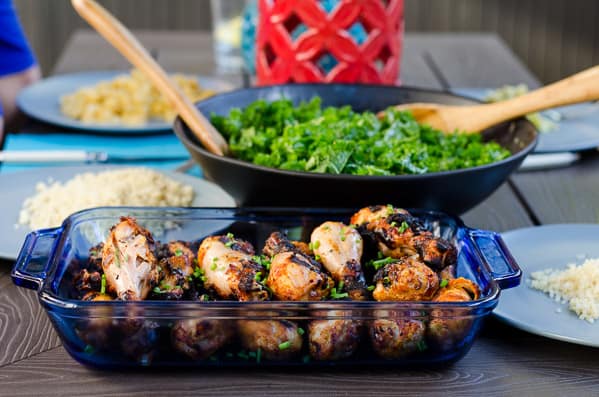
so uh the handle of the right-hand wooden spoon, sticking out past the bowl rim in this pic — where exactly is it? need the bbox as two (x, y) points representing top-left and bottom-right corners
(473, 66), (599, 131)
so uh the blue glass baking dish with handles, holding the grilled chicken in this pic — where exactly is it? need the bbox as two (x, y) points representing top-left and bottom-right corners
(12, 207), (521, 368)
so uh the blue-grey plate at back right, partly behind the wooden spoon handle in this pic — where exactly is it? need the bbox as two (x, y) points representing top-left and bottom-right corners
(451, 88), (599, 153)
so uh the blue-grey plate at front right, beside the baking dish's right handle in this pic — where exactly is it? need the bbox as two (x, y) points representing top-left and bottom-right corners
(493, 224), (599, 347)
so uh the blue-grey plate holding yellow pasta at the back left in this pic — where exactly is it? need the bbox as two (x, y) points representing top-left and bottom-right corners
(17, 70), (234, 134)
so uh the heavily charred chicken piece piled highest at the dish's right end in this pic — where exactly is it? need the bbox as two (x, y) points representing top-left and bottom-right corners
(351, 205), (457, 270)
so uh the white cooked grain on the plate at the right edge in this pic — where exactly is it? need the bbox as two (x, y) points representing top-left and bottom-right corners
(530, 258), (599, 323)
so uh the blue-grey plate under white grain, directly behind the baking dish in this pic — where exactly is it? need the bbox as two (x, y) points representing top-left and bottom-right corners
(0, 165), (235, 259)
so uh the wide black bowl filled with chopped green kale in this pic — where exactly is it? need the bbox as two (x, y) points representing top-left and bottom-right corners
(174, 84), (537, 214)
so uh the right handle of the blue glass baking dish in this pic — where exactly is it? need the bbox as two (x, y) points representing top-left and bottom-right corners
(468, 229), (522, 289)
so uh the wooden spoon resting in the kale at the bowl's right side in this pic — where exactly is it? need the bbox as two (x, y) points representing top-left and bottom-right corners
(379, 66), (599, 134)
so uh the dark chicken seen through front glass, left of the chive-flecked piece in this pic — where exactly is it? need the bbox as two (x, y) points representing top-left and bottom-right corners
(171, 319), (234, 360)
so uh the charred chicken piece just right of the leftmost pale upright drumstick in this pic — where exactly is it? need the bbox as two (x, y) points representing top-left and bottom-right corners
(154, 241), (195, 300)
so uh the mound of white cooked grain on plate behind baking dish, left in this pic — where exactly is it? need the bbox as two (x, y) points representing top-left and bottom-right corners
(19, 168), (194, 229)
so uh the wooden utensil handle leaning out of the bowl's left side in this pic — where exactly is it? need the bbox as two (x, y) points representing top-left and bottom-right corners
(71, 0), (228, 156)
